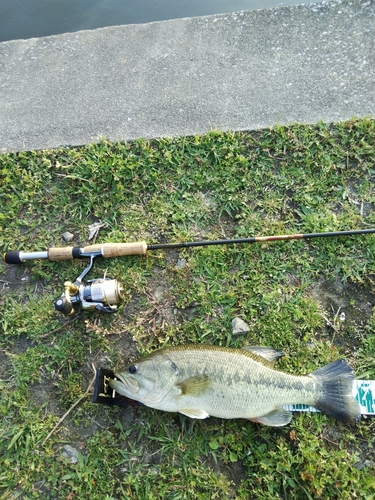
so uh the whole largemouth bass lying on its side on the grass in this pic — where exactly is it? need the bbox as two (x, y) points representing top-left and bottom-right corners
(109, 345), (360, 427)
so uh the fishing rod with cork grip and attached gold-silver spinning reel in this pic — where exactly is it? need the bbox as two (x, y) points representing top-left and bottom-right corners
(3, 229), (375, 315)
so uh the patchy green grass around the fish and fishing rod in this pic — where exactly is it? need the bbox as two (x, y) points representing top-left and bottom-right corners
(0, 119), (375, 500)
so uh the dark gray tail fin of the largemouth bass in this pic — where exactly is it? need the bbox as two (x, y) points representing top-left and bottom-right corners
(310, 359), (361, 422)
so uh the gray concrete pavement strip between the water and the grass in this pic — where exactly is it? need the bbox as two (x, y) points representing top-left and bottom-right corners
(0, 0), (375, 152)
